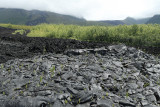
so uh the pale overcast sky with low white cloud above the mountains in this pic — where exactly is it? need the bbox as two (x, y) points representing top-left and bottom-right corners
(0, 0), (160, 20)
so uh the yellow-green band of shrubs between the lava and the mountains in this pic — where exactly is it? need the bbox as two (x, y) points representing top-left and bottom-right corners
(0, 24), (160, 46)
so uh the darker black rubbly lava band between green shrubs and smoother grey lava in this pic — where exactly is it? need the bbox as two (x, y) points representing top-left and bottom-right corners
(0, 27), (108, 63)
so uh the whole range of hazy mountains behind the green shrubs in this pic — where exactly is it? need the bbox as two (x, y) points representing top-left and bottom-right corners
(0, 8), (160, 25)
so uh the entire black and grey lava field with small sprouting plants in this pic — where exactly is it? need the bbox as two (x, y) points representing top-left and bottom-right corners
(0, 27), (160, 107)
